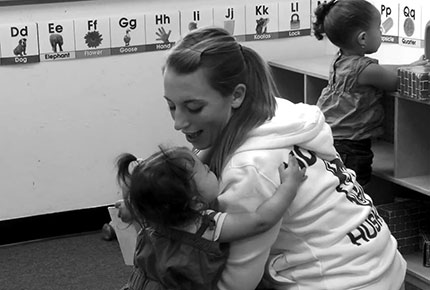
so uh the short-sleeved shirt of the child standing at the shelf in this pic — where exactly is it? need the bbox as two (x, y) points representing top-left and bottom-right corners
(317, 51), (384, 140)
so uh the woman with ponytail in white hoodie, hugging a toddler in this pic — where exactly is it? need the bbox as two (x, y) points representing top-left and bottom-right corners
(163, 28), (406, 290)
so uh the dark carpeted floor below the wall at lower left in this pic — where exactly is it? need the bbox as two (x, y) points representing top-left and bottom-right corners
(0, 231), (131, 290)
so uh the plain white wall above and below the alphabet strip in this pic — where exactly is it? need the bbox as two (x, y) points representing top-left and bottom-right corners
(0, 0), (332, 220)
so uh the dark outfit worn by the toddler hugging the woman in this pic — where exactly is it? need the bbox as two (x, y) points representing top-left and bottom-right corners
(123, 210), (228, 290)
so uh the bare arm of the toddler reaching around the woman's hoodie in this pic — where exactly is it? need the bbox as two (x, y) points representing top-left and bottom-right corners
(219, 154), (306, 242)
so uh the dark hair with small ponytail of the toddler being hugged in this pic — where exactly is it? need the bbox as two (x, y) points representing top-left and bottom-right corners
(116, 147), (200, 227)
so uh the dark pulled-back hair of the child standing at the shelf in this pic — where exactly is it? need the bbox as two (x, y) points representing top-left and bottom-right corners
(313, 0), (377, 48)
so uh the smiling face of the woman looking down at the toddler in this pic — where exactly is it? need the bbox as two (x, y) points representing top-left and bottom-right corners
(164, 67), (233, 150)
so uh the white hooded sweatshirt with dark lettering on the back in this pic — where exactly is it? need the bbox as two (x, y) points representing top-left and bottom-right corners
(218, 99), (406, 290)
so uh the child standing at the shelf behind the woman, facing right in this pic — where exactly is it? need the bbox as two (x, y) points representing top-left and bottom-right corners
(313, 0), (424, 186)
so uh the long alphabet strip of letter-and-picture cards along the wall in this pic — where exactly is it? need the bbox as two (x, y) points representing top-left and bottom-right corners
(0, 0), (430, 65)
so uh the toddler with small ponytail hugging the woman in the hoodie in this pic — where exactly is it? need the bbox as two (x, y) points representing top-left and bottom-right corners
(117, 147), (306, 290)
